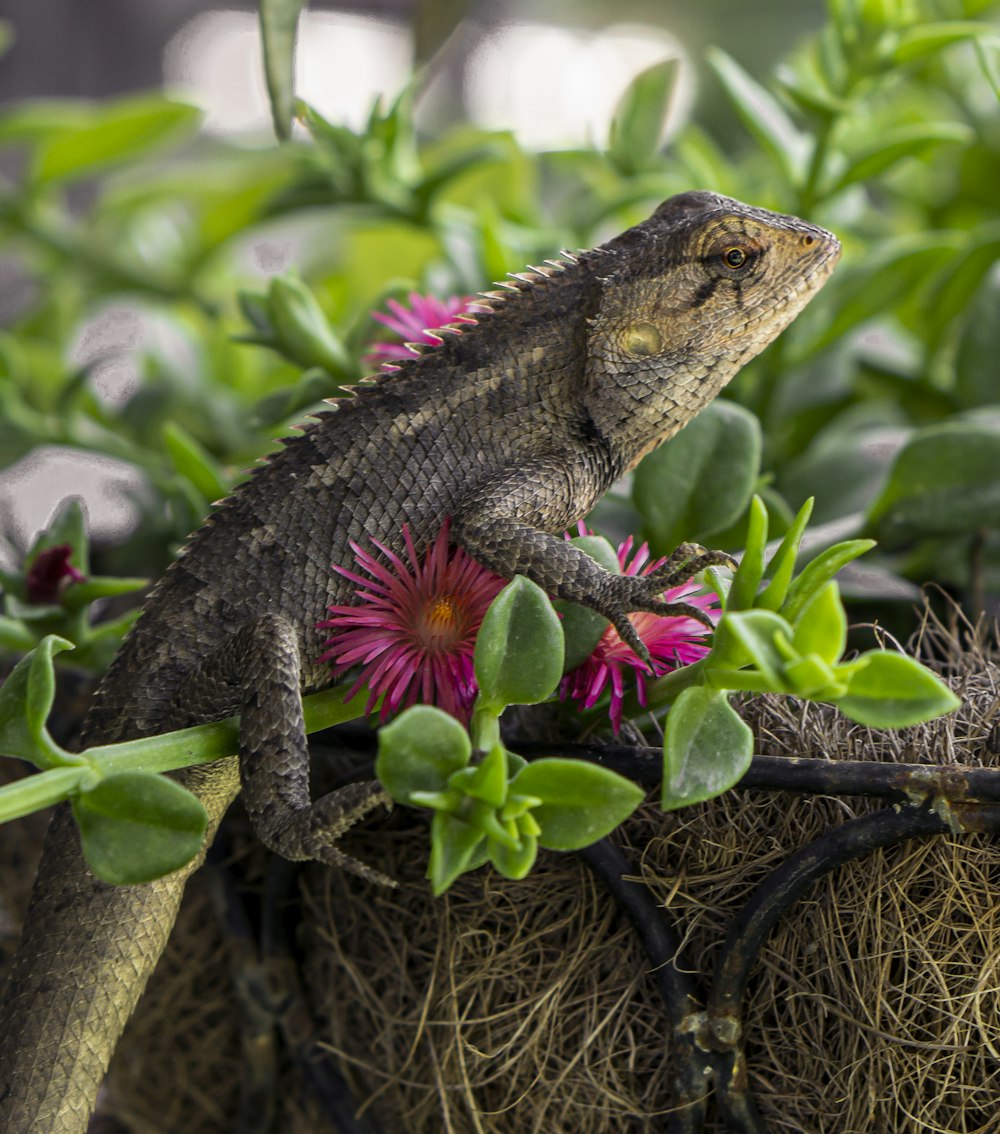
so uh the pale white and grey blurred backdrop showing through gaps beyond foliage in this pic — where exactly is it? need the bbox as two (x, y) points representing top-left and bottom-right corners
(0, 0), (823, 562)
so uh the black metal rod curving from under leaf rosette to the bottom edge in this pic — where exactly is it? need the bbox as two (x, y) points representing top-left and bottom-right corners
(577, 839), (714, 1134)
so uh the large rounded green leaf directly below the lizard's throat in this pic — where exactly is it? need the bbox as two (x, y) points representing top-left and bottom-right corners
(633, 401), (761, 553)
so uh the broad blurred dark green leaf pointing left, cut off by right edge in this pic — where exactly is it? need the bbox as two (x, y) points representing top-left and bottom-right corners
(868, 417), (1000, 535)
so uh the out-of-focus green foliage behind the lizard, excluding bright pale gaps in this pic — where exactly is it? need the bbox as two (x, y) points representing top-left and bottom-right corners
(0, 0), (1000, 657)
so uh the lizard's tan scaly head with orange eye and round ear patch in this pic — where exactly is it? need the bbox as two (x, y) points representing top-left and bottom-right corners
(586, 192), (840, 451)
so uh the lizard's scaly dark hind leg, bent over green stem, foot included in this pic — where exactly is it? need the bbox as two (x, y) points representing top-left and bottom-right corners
(173, 613), (396, 886)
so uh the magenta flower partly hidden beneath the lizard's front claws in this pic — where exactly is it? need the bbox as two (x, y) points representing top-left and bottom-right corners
(559, 531), (722, 733)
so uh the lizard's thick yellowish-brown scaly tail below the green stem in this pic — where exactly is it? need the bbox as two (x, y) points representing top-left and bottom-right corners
(0, 760), (238, 1134)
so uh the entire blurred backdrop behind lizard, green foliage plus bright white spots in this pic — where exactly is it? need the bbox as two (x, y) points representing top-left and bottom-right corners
(0, 0), (1000, 645)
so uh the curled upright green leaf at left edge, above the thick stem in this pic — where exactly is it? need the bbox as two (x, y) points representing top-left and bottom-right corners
(0, 634), (83, 769)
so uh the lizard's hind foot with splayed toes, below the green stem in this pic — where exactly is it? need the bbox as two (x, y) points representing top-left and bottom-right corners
(273, 781), (399, 887)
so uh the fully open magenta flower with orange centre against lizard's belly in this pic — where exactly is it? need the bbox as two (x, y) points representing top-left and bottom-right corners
(319, 522), (506, 722)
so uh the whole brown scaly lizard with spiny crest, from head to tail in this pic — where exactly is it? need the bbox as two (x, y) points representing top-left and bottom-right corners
(0, 191), (840, 1134)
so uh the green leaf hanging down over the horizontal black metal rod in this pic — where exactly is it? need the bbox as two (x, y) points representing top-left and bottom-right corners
(662, 685), (754, 811)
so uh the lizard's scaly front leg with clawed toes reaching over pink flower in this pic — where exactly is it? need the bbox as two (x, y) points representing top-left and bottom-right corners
(451, 466), (732, 665)
